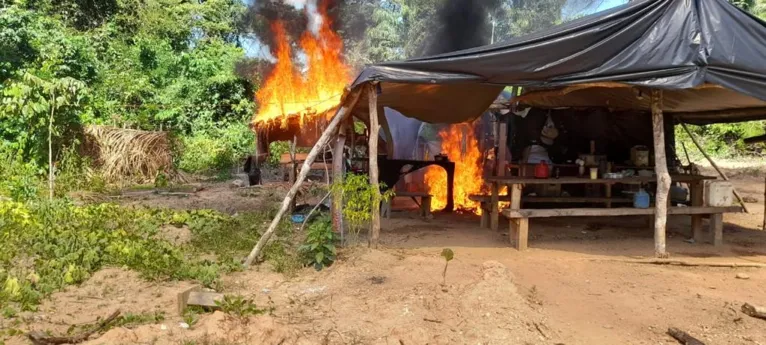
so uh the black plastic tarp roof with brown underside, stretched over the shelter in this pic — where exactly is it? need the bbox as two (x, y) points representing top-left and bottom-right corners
(352, 0), (766, 123)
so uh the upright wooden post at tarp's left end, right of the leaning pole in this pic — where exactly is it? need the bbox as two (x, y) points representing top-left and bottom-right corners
(367, 84), (382, 248)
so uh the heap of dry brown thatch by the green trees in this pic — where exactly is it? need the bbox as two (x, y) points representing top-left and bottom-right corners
(85, 126), (177, 183)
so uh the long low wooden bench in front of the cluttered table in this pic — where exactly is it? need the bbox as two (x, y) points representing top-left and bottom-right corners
(502, 206), (742, 250)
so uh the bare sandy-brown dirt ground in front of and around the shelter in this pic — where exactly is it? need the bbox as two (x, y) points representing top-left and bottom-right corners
(0, 167), (766, 345)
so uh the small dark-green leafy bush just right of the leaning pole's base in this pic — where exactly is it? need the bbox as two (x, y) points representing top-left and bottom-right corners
(299, 216), (337, 271)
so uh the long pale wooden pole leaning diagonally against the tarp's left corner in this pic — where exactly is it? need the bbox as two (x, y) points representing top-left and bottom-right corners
(245, 91), (360, 267)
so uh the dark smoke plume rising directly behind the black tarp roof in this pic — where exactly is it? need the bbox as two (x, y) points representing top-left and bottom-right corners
(422, 0), (501, 55)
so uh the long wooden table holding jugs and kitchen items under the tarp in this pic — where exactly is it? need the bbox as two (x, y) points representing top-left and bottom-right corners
(484, 174), (716, 235)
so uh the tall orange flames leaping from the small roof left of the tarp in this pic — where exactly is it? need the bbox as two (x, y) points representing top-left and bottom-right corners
(255, 2), (351, 124)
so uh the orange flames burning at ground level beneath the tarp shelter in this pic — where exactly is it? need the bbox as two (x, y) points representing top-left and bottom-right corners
(425, 124), (484, 214)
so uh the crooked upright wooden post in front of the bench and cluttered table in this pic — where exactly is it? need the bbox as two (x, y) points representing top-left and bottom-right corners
(652, 89), (670, 258)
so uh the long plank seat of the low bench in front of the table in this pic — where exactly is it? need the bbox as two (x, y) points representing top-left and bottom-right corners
(503, 206), (742, 218)
